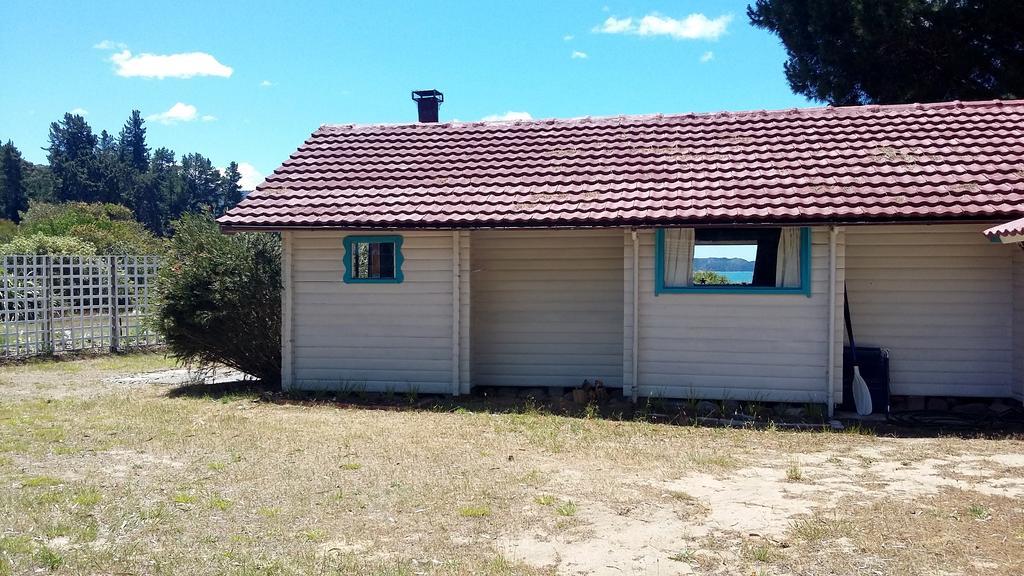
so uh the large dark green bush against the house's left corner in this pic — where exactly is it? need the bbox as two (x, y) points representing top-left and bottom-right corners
(156, 213), (281, 382)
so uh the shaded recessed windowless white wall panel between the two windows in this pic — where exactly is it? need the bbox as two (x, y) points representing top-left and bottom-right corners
(471, 229), (623, 387)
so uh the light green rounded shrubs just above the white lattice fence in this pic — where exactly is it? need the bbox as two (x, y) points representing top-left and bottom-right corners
(19, 202), (164, 254)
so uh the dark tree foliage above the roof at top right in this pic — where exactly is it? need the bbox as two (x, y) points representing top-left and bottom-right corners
(746, 0), (1024, 106)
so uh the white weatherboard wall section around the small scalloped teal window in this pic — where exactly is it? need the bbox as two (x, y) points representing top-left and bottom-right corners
(290, 231), (470, 394)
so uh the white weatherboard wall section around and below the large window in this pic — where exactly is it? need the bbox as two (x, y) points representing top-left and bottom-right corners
(620, 228), (844, 403)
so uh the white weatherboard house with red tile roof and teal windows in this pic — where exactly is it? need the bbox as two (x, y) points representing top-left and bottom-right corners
(220, 92), (1024, 409)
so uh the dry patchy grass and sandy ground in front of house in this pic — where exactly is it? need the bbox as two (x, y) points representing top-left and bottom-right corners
(0, 355), (1024, 575)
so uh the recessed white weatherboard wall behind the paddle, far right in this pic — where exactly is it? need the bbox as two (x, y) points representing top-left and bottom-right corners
(846, 224), (1014, 397)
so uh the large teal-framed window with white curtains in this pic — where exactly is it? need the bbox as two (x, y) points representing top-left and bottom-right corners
(654, 228), (811, 295)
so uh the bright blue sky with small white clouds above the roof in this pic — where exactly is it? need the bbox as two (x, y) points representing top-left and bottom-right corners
(0, 0), (810, 186)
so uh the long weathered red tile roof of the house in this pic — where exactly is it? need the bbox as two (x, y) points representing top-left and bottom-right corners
(220, 100), (1024, 229)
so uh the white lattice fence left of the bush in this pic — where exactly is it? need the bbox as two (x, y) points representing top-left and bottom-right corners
(0, 255), (162, 358)
